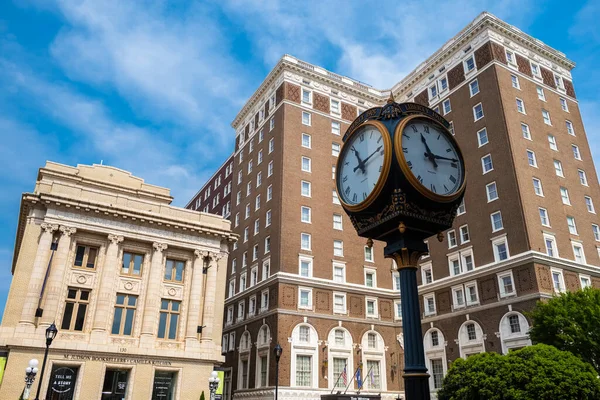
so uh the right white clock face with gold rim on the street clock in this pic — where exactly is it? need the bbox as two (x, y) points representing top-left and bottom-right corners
(397, 117), (465, 197)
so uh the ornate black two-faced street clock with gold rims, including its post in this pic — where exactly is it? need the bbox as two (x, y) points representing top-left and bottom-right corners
(336, 96), (466, 400)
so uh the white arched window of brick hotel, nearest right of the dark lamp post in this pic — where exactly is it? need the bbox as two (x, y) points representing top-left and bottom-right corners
(290, 323), (319, 388)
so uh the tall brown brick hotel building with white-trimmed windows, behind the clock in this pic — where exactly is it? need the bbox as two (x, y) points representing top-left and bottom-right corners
(188, 13), (600, 399)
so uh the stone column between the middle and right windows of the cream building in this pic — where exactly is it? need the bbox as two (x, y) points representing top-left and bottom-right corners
(140, 243), (167, 347)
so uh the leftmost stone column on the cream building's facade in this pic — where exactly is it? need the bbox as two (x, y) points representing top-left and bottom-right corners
(19, 222), (58, 326)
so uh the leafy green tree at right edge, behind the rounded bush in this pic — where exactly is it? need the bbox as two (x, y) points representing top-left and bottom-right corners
(529, 288), (600, 372)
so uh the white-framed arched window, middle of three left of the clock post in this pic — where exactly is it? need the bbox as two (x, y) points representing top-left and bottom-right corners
(327, 326), (356, 389)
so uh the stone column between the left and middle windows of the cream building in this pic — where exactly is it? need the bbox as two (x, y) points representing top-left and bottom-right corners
(92, 234), (123, 336)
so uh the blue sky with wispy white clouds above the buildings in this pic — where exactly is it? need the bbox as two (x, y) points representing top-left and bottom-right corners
(0, 0), (600, 309)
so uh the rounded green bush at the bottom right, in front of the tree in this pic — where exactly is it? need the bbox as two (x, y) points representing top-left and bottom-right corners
(438, 344), (600, 400)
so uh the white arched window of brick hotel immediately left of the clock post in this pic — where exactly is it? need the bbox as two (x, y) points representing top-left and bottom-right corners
(361, 330), (387, 392)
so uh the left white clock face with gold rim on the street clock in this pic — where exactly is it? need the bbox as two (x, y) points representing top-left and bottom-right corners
(337, 123), (391, 206)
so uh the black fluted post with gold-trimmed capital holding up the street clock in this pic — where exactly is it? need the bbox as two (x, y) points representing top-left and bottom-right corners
(384, 237), (430, 400)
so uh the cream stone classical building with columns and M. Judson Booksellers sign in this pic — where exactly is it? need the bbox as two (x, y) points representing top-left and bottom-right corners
(0, 162), (235, 400)
